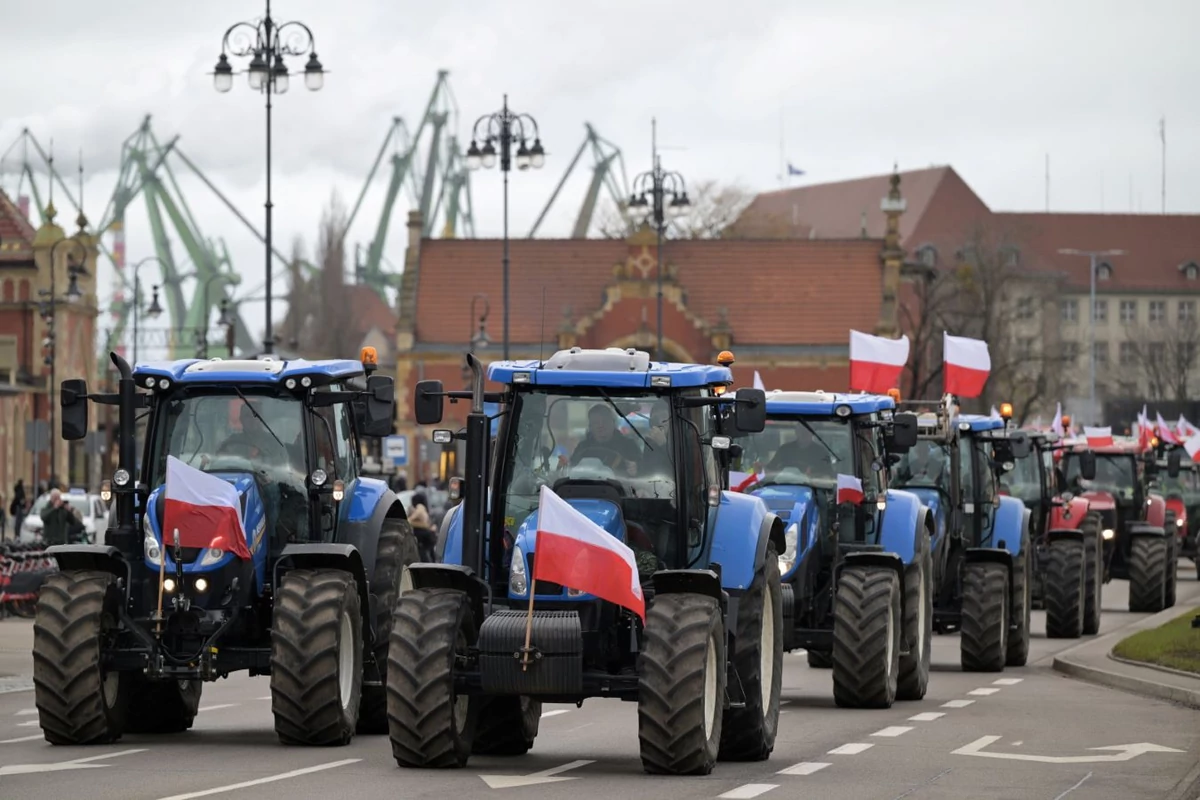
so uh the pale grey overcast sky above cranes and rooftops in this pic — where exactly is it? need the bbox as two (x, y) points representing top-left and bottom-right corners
(0, 0), (1200, 357)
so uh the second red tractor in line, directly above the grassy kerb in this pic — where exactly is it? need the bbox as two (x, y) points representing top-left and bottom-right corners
(1062, 437), (1178, 612)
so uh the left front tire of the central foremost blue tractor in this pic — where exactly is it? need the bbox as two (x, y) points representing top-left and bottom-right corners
(388, 589), (479, 768)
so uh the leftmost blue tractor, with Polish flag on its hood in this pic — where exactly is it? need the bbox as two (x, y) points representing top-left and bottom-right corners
(34, 348), (416, 745)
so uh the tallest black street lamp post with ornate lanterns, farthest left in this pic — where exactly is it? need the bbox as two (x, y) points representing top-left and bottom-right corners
(212, 0), (325, 354)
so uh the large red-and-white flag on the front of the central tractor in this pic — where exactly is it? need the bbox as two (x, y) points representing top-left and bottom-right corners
(533, 485), (646, 621)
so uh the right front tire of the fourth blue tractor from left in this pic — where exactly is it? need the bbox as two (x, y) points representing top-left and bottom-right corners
(959, 561), (1012, 672)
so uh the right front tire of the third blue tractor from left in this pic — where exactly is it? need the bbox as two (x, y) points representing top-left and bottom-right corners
(833, 566), (904, 709)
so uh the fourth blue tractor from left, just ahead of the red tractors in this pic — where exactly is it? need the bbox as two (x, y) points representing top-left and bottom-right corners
(892, 395), (1033, 672)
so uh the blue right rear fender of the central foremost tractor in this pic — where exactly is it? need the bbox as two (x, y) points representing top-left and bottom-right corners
(710, 492), (786, 594)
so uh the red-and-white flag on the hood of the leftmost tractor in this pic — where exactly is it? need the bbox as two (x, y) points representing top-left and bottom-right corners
(162, 456), (251, 560)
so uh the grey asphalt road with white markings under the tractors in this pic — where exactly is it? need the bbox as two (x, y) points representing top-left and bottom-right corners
(0, 569), (1200, 800)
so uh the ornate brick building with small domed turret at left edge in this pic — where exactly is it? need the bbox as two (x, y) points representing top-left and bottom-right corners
(0, 192), (98, 494)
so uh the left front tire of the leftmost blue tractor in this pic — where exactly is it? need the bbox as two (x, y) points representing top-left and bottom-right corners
(34, 570), (131, 745)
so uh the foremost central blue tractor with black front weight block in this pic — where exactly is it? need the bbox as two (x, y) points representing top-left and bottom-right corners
(388, 348), (785, 775)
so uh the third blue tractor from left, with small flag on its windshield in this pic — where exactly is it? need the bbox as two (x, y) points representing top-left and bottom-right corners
(724, 391), (934, 708)
